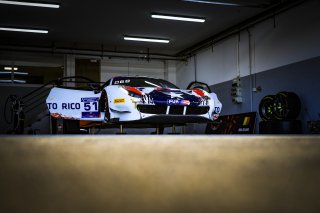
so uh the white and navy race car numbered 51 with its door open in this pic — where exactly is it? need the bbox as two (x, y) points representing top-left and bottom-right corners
(46, 76), (222, 129)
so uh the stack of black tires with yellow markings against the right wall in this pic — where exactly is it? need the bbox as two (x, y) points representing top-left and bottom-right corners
(259, 91), (302, 134)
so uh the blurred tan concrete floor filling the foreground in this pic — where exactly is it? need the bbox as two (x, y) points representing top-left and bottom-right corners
(0, 135), (320, 213)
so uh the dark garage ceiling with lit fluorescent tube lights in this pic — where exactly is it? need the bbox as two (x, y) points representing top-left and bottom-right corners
(0, 0), (304, 56)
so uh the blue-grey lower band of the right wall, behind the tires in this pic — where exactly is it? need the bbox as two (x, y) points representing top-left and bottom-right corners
(211, 57), (320, 133)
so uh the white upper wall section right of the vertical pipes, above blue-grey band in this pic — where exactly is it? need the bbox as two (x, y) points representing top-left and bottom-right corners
(253, 1), (320, 72)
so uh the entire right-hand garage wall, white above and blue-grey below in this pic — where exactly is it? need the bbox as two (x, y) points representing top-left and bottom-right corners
(177, 1), (320, 133)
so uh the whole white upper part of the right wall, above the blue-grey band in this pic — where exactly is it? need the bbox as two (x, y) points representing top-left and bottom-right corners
(177, 0), (320, 87)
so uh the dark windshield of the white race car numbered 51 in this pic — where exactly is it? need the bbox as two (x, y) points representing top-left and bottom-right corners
(112, 77), (178, 89)
